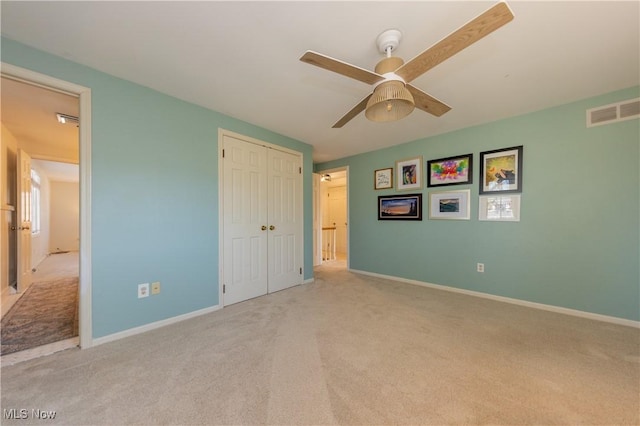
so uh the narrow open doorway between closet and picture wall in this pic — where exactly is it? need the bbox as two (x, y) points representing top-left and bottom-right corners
(314, 167), (349, 268)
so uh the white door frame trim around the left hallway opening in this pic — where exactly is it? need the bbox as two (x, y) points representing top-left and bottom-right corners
(0, 62), (93, 348)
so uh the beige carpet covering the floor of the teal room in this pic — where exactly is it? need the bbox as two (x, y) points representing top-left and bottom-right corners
(1, 267), (640, 425)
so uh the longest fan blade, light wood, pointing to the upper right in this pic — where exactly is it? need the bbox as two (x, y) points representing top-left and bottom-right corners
(395, 3), (513, 83)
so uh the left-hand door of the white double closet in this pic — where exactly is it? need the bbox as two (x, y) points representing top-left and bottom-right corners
(221, 136), (268, 305)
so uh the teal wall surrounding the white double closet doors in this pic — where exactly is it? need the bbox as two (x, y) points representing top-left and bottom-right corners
(1, 38), (313, 338)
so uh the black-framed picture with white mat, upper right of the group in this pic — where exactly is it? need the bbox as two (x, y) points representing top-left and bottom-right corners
(480, 145), (522, 194)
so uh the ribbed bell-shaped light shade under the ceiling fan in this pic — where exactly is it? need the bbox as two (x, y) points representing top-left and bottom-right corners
(364, 80), (415, 123)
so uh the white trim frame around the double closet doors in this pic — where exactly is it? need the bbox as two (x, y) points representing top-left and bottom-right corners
(218, 127), (304, 308)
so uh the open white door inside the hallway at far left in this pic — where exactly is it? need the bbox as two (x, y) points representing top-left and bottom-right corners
(16, 149), (31, 292)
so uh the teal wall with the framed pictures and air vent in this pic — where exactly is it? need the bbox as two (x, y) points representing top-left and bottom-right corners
(315, 87), (640, 321)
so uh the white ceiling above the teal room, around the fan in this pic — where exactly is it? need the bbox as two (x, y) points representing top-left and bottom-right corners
(1, 0), (640, 162)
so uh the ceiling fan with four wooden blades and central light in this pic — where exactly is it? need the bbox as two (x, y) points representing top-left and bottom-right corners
(300, 2), (513, 128)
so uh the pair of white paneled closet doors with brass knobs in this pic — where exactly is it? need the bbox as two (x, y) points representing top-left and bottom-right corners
(220, 132), (303, 305)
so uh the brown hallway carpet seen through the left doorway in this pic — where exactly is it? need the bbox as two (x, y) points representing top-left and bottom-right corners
(0, 277), (78, 355)
